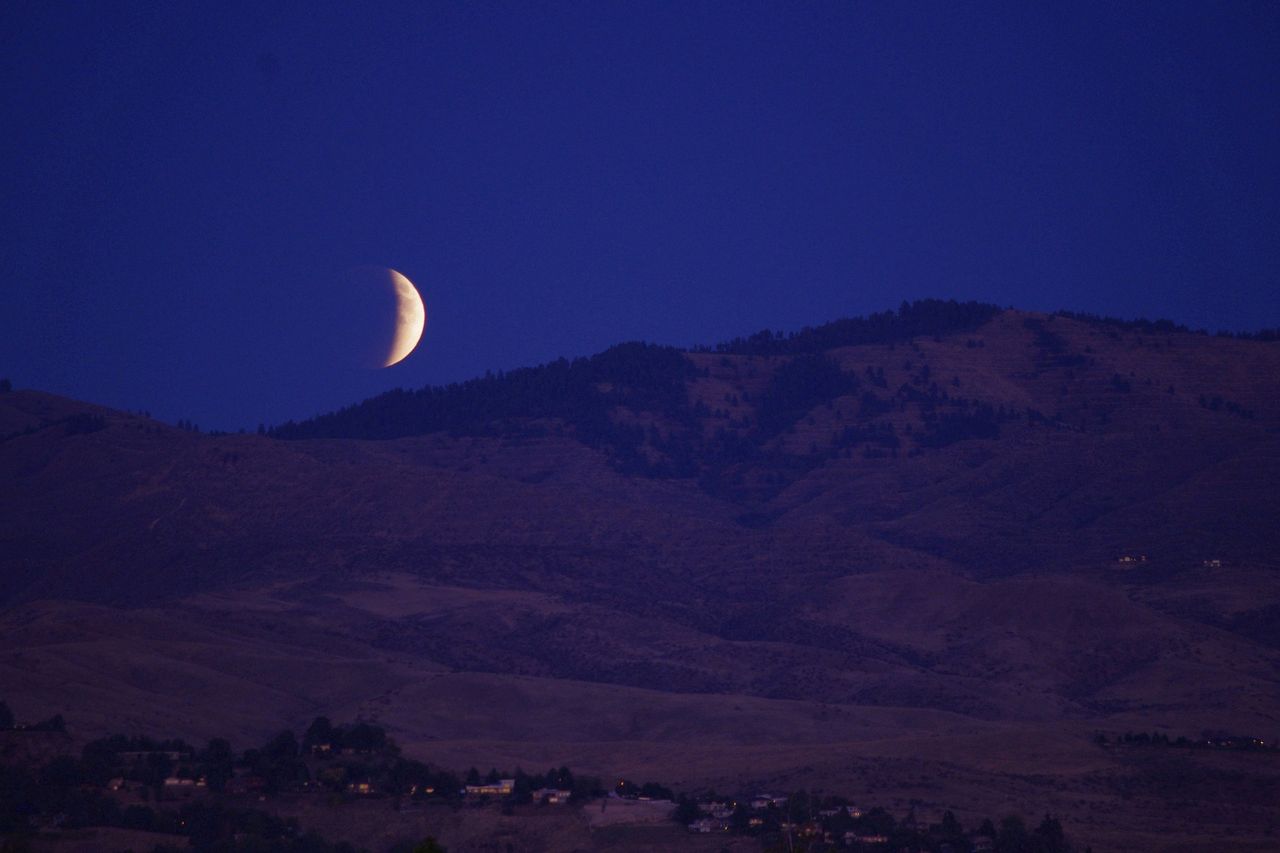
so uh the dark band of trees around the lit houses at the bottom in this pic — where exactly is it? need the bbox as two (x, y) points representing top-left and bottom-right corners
(0, 703), (1090, 853)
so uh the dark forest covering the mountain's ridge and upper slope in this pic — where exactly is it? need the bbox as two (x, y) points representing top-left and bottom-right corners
(259, 300), (1100, 498)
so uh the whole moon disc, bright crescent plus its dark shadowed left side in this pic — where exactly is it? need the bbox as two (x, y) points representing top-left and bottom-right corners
(324, 266), (426, 369)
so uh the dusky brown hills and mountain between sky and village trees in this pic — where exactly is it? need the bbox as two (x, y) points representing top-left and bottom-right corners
(0, 304), (1280, 850)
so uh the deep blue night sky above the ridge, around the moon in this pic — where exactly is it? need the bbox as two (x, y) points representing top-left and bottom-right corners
(0, 1), (1280, 429)
